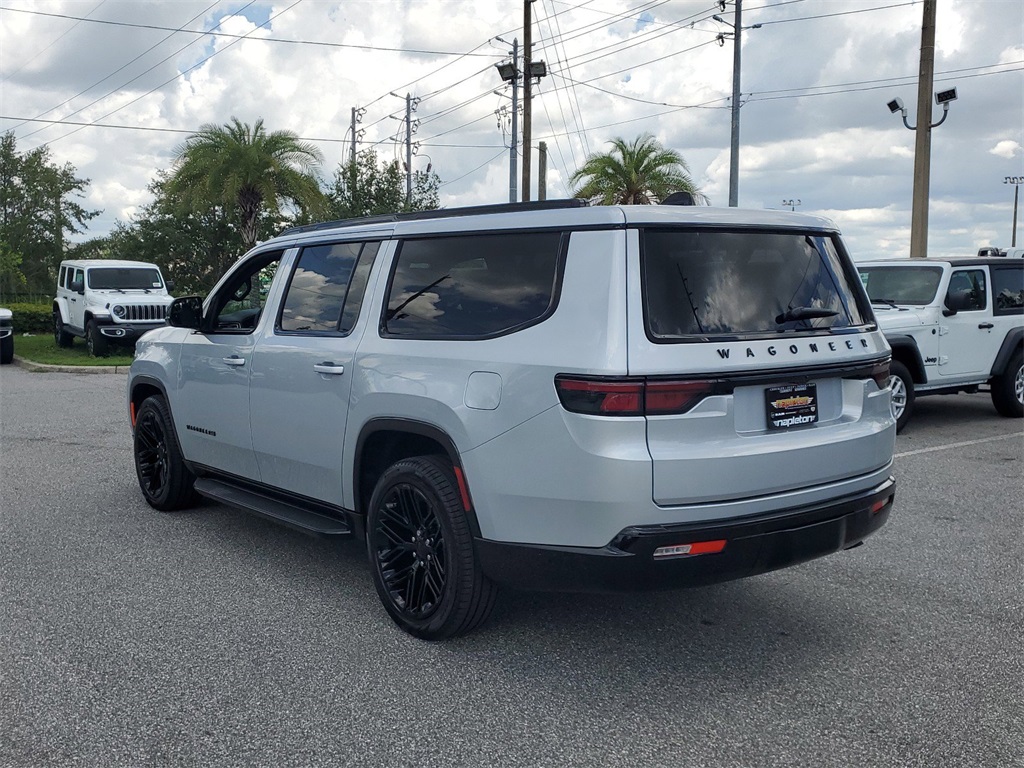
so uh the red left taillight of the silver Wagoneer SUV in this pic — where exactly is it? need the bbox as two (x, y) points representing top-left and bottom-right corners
(555, 376), (715, 416)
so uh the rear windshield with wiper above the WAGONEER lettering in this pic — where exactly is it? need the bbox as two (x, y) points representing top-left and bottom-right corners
(642, 229), (865, 341)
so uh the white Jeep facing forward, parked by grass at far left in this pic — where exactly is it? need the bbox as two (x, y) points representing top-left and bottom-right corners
(53, 259), (173, 356)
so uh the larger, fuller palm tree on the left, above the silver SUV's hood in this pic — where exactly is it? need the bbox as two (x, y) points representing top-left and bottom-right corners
(167, 117), (324, 250)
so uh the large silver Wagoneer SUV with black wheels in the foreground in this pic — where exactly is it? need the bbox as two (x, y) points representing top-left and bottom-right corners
(128, 201), (895, 639)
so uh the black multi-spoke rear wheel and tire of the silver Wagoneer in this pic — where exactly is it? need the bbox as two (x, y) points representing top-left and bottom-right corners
(367, 456), (498, 640)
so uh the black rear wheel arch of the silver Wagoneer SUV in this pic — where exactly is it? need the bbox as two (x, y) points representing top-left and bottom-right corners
(352, 418), (480, 538)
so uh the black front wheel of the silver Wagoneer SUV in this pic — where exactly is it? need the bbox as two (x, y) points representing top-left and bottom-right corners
(132, 396), (197, 512)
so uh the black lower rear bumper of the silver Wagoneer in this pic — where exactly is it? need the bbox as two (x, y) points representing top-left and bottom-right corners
(476, 477), (896, 592)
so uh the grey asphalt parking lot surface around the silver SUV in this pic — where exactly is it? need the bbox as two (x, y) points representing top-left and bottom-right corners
(0, 367), (1024, 768)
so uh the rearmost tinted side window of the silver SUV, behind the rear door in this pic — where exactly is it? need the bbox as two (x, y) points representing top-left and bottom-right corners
(383, 231), (562, 339)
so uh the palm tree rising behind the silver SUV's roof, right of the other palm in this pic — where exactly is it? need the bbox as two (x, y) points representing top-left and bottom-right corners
(569, 133), (708, 206)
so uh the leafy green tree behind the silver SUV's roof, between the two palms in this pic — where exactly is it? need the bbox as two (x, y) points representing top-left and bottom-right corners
(327, 150), (440, 219)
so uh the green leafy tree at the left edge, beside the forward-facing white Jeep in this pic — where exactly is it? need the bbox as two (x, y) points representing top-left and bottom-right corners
(0, 131), (99, 293)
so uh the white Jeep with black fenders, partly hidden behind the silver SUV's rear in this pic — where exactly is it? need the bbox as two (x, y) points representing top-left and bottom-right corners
(857, 257), (1024, 429)
